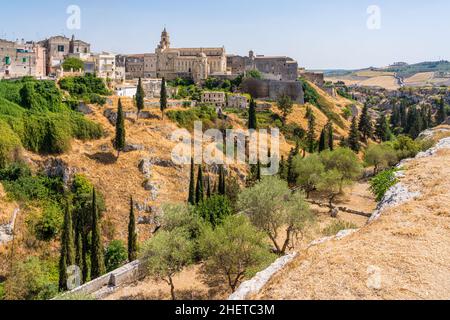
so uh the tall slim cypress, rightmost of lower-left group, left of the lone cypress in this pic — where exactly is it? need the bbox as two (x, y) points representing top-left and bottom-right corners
(91, 189), (106, 280)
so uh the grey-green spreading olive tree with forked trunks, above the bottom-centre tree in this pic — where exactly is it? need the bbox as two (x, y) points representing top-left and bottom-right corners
(238, 177), (313, 255)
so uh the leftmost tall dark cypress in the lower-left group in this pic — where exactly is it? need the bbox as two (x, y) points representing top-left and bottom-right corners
(59, 202), (75, 291)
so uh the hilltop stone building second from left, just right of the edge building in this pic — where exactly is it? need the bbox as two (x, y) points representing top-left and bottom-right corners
(39, 36), (91, 75)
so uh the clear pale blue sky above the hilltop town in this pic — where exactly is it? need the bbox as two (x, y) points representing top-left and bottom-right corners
(0, 0), (450, 69)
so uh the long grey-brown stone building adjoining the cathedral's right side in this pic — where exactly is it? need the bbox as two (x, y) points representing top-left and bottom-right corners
(227, 51), (298, 81)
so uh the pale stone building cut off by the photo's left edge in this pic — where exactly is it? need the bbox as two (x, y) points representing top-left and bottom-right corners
(0, 39), (46, 79)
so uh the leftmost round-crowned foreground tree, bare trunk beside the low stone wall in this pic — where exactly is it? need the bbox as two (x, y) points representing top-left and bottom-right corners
(142, 228), (194, 300)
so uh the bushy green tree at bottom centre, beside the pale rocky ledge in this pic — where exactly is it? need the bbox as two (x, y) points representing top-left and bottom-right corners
(199, 215), (275, 292)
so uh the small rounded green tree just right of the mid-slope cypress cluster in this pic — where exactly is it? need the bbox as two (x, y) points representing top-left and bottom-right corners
(294, 154), (325, 199)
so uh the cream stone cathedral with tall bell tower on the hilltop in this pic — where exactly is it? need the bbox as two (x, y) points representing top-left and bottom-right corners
(155, 28), (227, 83)
